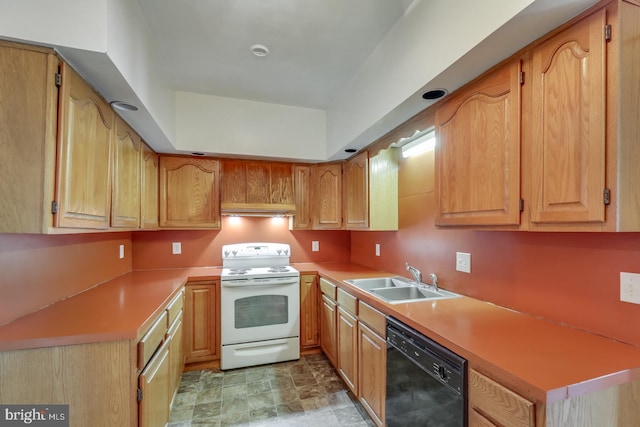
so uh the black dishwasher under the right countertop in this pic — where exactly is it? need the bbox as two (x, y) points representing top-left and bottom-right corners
(385, 317), (467, 427)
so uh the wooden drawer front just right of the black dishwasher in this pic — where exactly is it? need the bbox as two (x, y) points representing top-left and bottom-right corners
(469, 369), (535, 427)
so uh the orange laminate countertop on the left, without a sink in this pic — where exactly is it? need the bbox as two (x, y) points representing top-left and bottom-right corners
(0, 268), (220, 351)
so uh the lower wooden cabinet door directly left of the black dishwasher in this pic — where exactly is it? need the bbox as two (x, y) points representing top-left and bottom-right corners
(358, 322), (387, 426)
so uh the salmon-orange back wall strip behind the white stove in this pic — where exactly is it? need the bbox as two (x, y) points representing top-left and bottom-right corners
(133, 216), (350, 270)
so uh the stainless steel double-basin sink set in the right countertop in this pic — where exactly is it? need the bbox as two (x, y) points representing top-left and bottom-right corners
(345, 276), (460, 304)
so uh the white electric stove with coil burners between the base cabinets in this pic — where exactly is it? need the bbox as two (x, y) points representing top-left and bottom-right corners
(220, 243), (300, 369)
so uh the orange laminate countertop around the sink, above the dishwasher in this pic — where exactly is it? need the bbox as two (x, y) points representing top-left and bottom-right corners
(308, 264), (640, 403)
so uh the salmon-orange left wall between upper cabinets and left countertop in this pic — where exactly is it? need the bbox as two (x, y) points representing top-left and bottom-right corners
(0, 233), (132, 325)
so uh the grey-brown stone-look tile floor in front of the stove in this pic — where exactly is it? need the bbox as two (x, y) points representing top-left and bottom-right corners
(169, 354), (374, 427)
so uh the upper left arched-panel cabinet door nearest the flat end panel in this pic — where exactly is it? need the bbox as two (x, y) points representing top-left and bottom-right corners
(55, 64), (114, 229)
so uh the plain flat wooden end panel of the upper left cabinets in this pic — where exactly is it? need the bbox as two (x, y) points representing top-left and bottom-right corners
(0, 41), (60, 233)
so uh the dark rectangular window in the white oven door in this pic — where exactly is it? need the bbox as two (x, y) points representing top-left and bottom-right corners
(234, 295), (289, 329)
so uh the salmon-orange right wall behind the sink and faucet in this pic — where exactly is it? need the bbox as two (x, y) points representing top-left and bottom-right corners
(351, 149), (640, 346)
